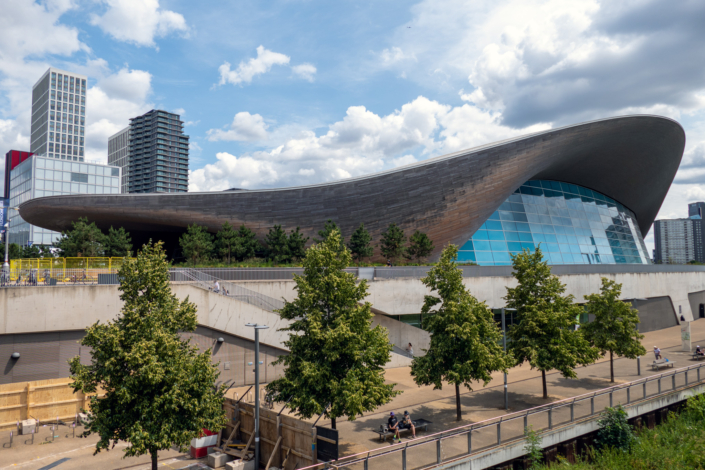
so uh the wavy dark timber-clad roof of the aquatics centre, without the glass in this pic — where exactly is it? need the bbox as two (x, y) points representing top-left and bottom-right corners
(20, 116), (685, 255)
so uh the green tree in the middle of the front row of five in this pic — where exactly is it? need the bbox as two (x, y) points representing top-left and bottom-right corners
(411, 245), (513, 421)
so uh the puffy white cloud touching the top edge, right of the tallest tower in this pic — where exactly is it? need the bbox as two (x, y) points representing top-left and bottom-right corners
(91, 0), (188, 47)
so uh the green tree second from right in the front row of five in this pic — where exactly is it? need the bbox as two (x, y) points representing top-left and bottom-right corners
(505, 247), (599, 398)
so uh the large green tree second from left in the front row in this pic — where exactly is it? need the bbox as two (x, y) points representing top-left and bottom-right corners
(267, 230), (400, 429)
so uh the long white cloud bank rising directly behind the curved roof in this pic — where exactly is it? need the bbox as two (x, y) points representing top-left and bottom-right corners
(189, 96), (547, 191)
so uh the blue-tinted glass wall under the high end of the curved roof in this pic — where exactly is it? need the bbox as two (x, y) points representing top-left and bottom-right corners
(458, 180), (651, 266)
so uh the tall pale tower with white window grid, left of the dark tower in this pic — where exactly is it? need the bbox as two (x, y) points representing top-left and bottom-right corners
(29, 67), (86, 162)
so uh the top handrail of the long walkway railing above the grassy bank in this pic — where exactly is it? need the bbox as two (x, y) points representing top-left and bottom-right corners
(300, 363), (705, 470)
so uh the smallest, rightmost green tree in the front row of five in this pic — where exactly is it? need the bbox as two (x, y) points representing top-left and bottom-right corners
(580, 277), (646, 382)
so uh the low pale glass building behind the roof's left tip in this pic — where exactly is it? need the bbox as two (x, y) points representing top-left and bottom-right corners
(10, 155), (120, 246)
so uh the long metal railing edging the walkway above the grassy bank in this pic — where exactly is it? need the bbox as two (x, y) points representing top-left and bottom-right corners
(301, 364), (705, 470)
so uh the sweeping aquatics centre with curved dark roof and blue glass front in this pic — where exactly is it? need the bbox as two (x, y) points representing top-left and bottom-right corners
(20, 115), (685, 266)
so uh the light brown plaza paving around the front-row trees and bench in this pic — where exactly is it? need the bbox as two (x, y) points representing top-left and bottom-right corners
(0, 320), (705, 470)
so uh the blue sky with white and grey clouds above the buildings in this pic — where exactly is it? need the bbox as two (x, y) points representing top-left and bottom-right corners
(0, 0), (705, 247)
